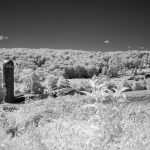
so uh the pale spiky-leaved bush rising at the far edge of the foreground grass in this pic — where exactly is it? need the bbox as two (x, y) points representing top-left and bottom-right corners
(82, 75), (128, 103)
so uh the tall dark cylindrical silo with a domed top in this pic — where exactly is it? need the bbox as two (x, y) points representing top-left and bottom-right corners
(3, 59), (14, 103)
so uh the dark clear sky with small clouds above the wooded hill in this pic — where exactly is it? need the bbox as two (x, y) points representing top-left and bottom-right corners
(0, 0), (150, 51)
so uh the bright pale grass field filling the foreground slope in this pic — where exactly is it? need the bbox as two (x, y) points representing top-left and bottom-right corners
(0, 92), (150, 150)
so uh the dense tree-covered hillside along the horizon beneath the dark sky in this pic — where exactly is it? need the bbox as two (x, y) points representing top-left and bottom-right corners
(0, 48), (150, 78)
